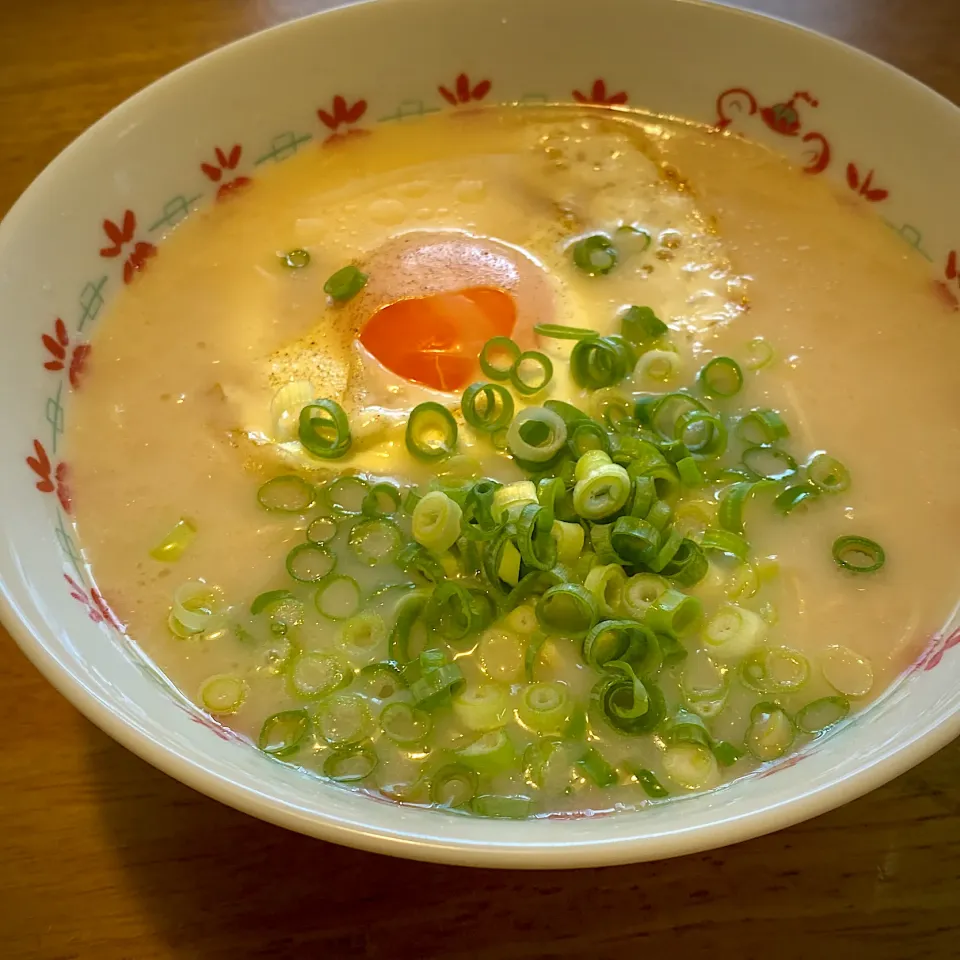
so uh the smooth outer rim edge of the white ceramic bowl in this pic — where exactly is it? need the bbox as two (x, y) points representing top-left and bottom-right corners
(0, 0), (960, 869)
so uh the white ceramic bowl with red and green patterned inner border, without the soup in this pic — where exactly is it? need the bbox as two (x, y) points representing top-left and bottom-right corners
(0, 0), (960, 867)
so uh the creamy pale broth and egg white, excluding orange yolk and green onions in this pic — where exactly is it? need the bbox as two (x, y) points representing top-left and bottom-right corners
(69, 108), (960, 813)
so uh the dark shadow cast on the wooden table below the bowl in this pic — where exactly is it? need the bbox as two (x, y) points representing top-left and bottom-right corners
(89, 727), (960, 960)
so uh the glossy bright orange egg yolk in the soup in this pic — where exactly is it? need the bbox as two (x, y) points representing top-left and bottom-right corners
(360, 287), (517, 392)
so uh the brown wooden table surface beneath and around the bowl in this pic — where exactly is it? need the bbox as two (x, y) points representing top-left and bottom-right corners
(0, 0), (960, 960)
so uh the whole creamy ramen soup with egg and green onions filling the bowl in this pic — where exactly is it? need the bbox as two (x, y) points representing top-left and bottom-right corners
(69, 107), (960, 817)
